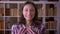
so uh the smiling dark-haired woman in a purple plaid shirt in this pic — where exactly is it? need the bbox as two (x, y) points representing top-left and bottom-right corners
(12, 2), (45, 34)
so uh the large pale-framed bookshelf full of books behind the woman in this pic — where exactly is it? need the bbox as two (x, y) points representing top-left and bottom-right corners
(0, 0), (59, 34)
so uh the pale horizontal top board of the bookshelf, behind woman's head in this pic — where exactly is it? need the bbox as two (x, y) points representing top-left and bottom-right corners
(0, 1), (57, 4)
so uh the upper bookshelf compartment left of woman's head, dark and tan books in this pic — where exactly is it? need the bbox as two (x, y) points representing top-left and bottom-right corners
(5, 3), (18, 16)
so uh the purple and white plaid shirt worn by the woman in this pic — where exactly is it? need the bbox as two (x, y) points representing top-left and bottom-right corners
(11, 24), (45, 34)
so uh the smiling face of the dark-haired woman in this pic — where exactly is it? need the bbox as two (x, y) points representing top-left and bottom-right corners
(23, 4), (35, 20)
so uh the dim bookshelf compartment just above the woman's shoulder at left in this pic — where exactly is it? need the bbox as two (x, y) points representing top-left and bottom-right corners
(5, 17), (17, 29)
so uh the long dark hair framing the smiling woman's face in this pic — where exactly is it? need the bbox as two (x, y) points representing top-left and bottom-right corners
(20, 1), (38, 26)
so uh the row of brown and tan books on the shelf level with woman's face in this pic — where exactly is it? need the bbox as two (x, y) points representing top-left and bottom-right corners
(0, 8), (57, 16)
